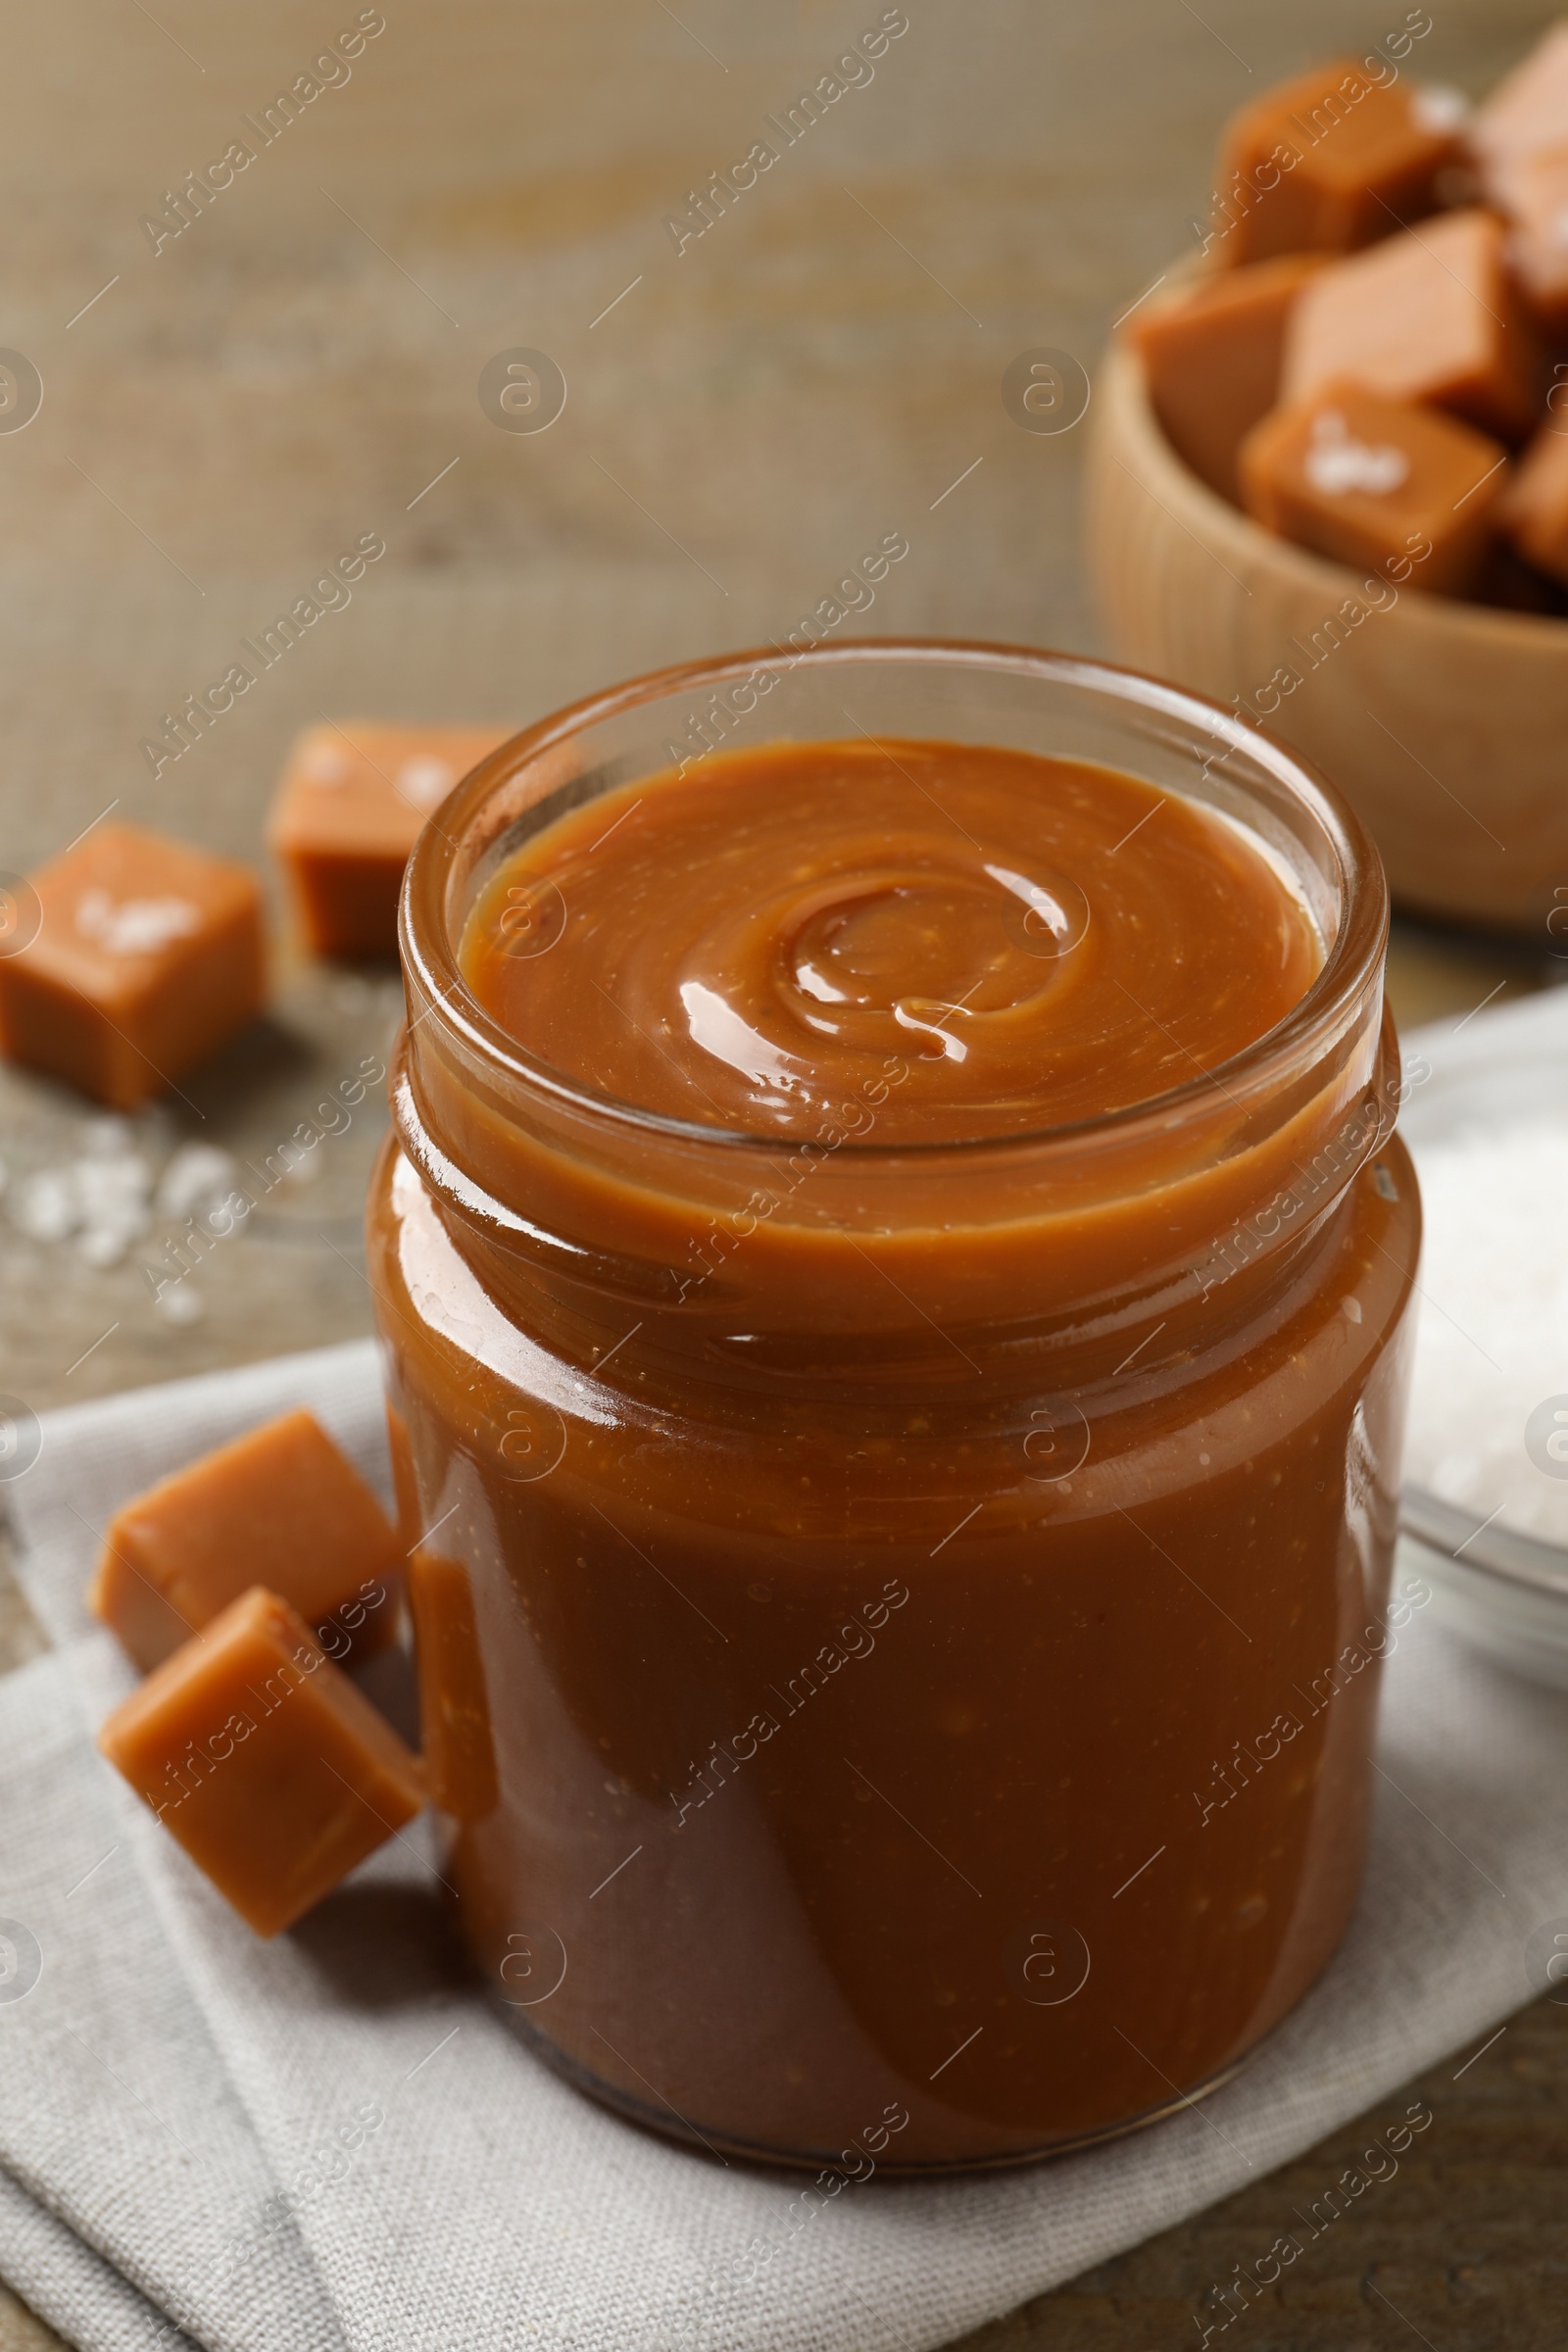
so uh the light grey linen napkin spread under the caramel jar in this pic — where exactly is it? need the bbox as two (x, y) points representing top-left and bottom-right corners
(0, 993), (1568, 2352)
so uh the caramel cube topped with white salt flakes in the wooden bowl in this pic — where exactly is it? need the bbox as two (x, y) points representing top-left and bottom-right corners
(1242, 383), (1507, 595)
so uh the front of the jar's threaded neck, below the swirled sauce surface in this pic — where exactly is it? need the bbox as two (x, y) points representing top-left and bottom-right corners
(393, 971), (1398, 1395)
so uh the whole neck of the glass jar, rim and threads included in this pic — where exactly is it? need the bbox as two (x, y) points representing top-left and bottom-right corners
(395, 640), (1396, 1386)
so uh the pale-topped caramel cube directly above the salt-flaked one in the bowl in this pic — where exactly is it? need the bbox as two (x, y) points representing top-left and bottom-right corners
(1284, 212), (1538, 440)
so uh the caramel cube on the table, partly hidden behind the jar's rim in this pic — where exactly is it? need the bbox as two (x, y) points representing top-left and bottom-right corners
(268, 719), (508, 955)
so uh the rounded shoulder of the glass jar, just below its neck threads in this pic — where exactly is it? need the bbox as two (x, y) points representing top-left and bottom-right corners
(369, 1141), (1420, 1539)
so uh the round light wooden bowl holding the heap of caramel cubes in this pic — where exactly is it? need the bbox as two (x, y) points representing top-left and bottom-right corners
(1089, 346), (1568, 946)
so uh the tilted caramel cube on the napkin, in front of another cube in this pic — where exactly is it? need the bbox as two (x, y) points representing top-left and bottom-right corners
(99, 1586), (425, 1936)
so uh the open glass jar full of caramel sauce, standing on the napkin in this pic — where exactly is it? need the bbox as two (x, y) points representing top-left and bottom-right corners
(369, 642), (1417, 2171)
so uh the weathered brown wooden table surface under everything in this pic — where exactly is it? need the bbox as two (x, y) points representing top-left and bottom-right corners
(0, 0), (1568, 2352)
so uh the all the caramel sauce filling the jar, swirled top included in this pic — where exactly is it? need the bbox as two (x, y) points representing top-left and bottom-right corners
(371, 719), (1417, 2169)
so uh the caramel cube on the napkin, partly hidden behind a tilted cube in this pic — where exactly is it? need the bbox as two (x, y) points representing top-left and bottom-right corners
(87, 1411), (402, 1672)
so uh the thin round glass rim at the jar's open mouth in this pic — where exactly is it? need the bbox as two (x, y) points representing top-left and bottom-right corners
(397, 637), (1390, 1164)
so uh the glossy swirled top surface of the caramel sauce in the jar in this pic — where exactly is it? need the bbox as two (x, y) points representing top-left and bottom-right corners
(461, 743), (1321, 1143)
